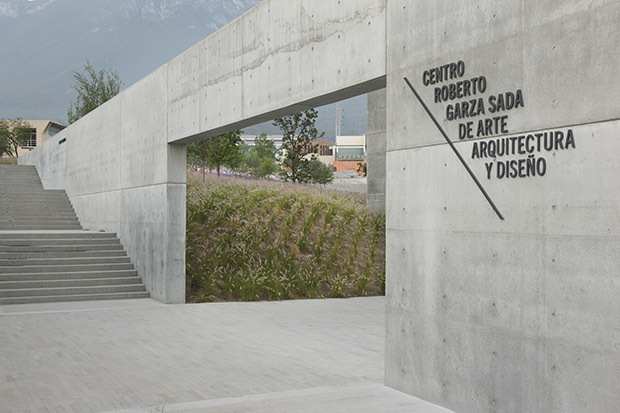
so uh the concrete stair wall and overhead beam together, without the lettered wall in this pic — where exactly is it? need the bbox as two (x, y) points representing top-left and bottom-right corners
(20, 0), (386, 303)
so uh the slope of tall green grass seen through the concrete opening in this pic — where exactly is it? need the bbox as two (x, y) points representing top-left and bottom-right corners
(187, 173), (385, 302)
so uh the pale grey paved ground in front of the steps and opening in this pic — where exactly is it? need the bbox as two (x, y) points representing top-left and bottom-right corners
(0, 297), (447, 413)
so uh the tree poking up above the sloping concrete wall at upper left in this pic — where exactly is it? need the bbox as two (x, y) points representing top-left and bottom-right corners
(67, 59), (122, 123)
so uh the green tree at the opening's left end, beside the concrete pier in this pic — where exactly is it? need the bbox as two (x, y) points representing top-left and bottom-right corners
(187, 130), (241, 180)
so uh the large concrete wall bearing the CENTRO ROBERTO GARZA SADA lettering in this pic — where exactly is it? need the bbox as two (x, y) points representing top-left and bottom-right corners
(386, 0), (620, 412)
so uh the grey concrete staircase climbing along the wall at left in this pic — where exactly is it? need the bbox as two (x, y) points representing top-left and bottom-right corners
(0, 165), (149, 305)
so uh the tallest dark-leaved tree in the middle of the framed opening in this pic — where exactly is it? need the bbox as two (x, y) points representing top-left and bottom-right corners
(273, 109), (325, 182)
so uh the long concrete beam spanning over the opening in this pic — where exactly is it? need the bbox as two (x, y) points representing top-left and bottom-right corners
(168, 0), (386, 143)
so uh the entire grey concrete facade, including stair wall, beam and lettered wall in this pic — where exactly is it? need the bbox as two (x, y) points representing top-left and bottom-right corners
(17, 0), (620, 412)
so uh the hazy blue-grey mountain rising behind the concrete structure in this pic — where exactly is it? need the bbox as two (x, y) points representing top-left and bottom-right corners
(0, 0), (366, 139)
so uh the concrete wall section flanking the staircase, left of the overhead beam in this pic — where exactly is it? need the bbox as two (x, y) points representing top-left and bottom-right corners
(19, 66), (185, 303)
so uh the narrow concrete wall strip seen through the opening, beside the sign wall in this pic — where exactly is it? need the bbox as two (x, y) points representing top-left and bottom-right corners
(366, 89), (387, 211)
